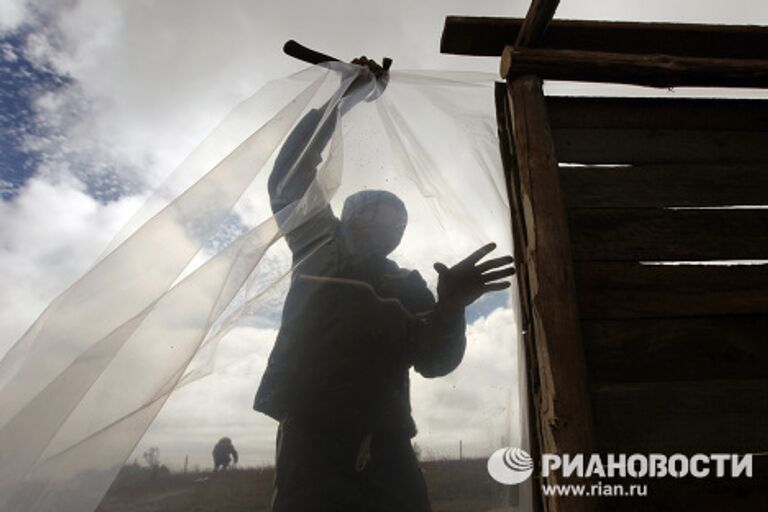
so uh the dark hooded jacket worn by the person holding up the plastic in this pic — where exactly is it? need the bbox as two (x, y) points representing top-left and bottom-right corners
(254, 110), (466, 436)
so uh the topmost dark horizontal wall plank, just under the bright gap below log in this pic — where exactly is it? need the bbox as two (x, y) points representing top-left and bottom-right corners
(547, 96), (768, 132)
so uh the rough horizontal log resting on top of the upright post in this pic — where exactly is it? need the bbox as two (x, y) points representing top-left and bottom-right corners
(500, 46), (768, 88)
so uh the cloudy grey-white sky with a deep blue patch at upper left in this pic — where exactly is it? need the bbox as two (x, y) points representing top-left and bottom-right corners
(0, 0), (768, 476)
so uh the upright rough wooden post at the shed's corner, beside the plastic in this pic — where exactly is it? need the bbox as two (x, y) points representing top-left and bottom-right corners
(509, 77), (595, 510)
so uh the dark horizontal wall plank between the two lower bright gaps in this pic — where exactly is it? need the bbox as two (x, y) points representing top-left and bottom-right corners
(568, 208), (768, 261)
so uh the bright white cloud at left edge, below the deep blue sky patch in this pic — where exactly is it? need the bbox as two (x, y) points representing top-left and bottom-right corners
(0, 179), (138, 353)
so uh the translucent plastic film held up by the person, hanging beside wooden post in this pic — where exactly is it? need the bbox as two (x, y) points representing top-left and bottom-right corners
(0, 63), (527, 512)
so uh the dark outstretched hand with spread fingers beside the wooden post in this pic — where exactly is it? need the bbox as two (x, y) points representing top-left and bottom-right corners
(435, 243), (515, 308)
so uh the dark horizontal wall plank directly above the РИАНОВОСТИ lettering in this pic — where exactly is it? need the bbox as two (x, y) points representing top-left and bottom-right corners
(592, 379), (768, 453)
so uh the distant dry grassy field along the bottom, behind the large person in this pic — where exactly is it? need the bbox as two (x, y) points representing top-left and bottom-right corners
(97, 459), (510, 512)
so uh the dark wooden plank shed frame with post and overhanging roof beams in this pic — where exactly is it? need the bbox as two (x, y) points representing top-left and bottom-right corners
(441, 0), (768, 511)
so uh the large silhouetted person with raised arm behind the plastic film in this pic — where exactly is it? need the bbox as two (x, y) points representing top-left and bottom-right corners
(254, 59), (513, 512)
